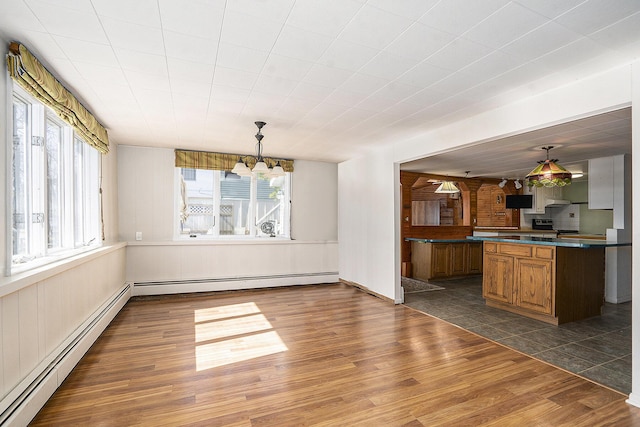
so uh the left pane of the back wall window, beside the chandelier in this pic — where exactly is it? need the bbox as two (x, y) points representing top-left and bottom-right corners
(180, 169), (215, 235)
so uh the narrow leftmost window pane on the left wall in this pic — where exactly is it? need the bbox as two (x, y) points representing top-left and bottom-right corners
(12, 100), (29, 262)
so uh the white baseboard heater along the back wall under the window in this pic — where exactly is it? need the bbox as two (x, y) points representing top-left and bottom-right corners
(132, 271), (339, 296)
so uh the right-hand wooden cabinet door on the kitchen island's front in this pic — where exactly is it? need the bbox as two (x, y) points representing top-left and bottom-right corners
(515, 258), (554, 314)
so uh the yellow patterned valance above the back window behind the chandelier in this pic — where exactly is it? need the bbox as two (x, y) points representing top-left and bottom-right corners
(175, 150), (293, 172)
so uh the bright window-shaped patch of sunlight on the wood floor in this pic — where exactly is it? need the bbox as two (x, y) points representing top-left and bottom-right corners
(194, 302), (288, 371)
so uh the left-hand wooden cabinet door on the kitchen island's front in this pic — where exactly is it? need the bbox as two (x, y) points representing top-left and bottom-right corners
(482, 254), (514, 304)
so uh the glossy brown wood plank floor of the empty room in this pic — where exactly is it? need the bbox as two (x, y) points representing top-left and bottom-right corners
(32, 284), (640, 427)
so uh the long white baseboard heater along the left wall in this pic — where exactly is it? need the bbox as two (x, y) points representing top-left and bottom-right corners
(0, 283), (132, 427)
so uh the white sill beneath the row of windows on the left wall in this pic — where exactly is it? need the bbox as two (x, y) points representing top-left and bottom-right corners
(0, 242), (127, 298)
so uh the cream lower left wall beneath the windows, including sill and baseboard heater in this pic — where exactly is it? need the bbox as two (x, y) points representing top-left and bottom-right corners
(0, 244), (131, 425)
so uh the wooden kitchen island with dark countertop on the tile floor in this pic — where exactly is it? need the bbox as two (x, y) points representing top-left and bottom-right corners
(467, 236), (631, 325)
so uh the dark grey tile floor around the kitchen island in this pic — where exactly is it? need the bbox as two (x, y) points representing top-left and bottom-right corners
(405, 276), (631, 394)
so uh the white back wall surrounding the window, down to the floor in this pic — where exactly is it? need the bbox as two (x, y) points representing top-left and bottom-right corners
(118, 146), (338, 294)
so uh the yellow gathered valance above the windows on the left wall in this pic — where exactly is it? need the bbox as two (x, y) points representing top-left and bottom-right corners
(7, 42), (109, 154)
